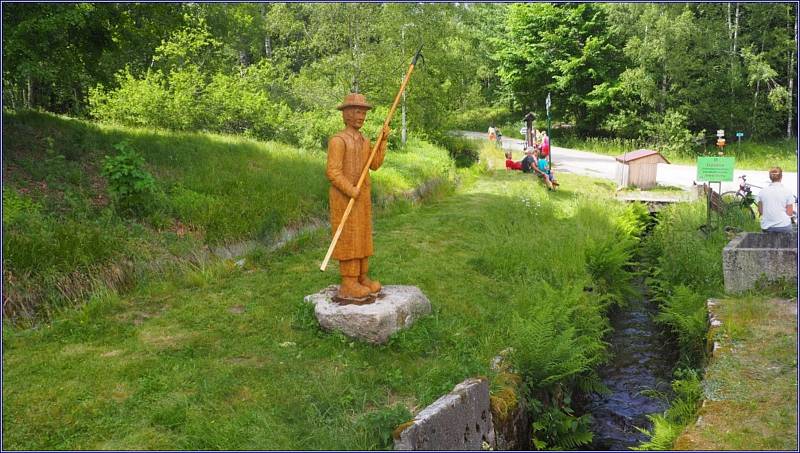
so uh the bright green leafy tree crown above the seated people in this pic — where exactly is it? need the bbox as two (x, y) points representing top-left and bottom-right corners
(496, 3), (625, 131)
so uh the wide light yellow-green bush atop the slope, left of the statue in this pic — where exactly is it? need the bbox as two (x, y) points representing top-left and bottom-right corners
(89, 61), (298, 143)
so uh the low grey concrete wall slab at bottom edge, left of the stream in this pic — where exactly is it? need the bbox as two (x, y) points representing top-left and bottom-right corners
(394, 379), (495, 450)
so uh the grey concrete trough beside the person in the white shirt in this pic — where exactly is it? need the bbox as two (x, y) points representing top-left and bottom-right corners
(722, 233), (797, 294)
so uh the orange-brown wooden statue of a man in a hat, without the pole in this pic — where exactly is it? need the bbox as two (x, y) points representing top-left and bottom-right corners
(325, 93), (389, 299)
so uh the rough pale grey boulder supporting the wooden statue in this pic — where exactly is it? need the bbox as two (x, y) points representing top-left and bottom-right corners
(305, 285), (431, 344)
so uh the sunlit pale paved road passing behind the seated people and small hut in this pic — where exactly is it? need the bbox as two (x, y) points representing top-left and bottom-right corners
(459, 131), (798, 195)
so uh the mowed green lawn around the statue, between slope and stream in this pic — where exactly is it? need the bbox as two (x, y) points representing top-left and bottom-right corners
(3, 166), (623, 449)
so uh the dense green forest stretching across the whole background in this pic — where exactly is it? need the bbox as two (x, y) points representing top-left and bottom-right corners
(3, 2), (797, 150)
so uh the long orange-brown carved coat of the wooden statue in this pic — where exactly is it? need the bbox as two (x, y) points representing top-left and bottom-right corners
(325, 129), (386, 260)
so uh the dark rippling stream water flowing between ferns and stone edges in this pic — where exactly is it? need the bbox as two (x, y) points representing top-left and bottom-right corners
(582, 282), (677, 450)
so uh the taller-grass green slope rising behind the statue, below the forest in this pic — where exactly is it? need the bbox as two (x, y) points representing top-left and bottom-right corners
(3, 112), (455, 320)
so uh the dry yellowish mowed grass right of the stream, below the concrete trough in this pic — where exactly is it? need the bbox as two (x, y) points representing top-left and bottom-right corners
(675, 295), (797, 451)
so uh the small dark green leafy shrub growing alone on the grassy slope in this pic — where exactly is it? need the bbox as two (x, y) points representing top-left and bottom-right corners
(101, 141), (159, 216)
